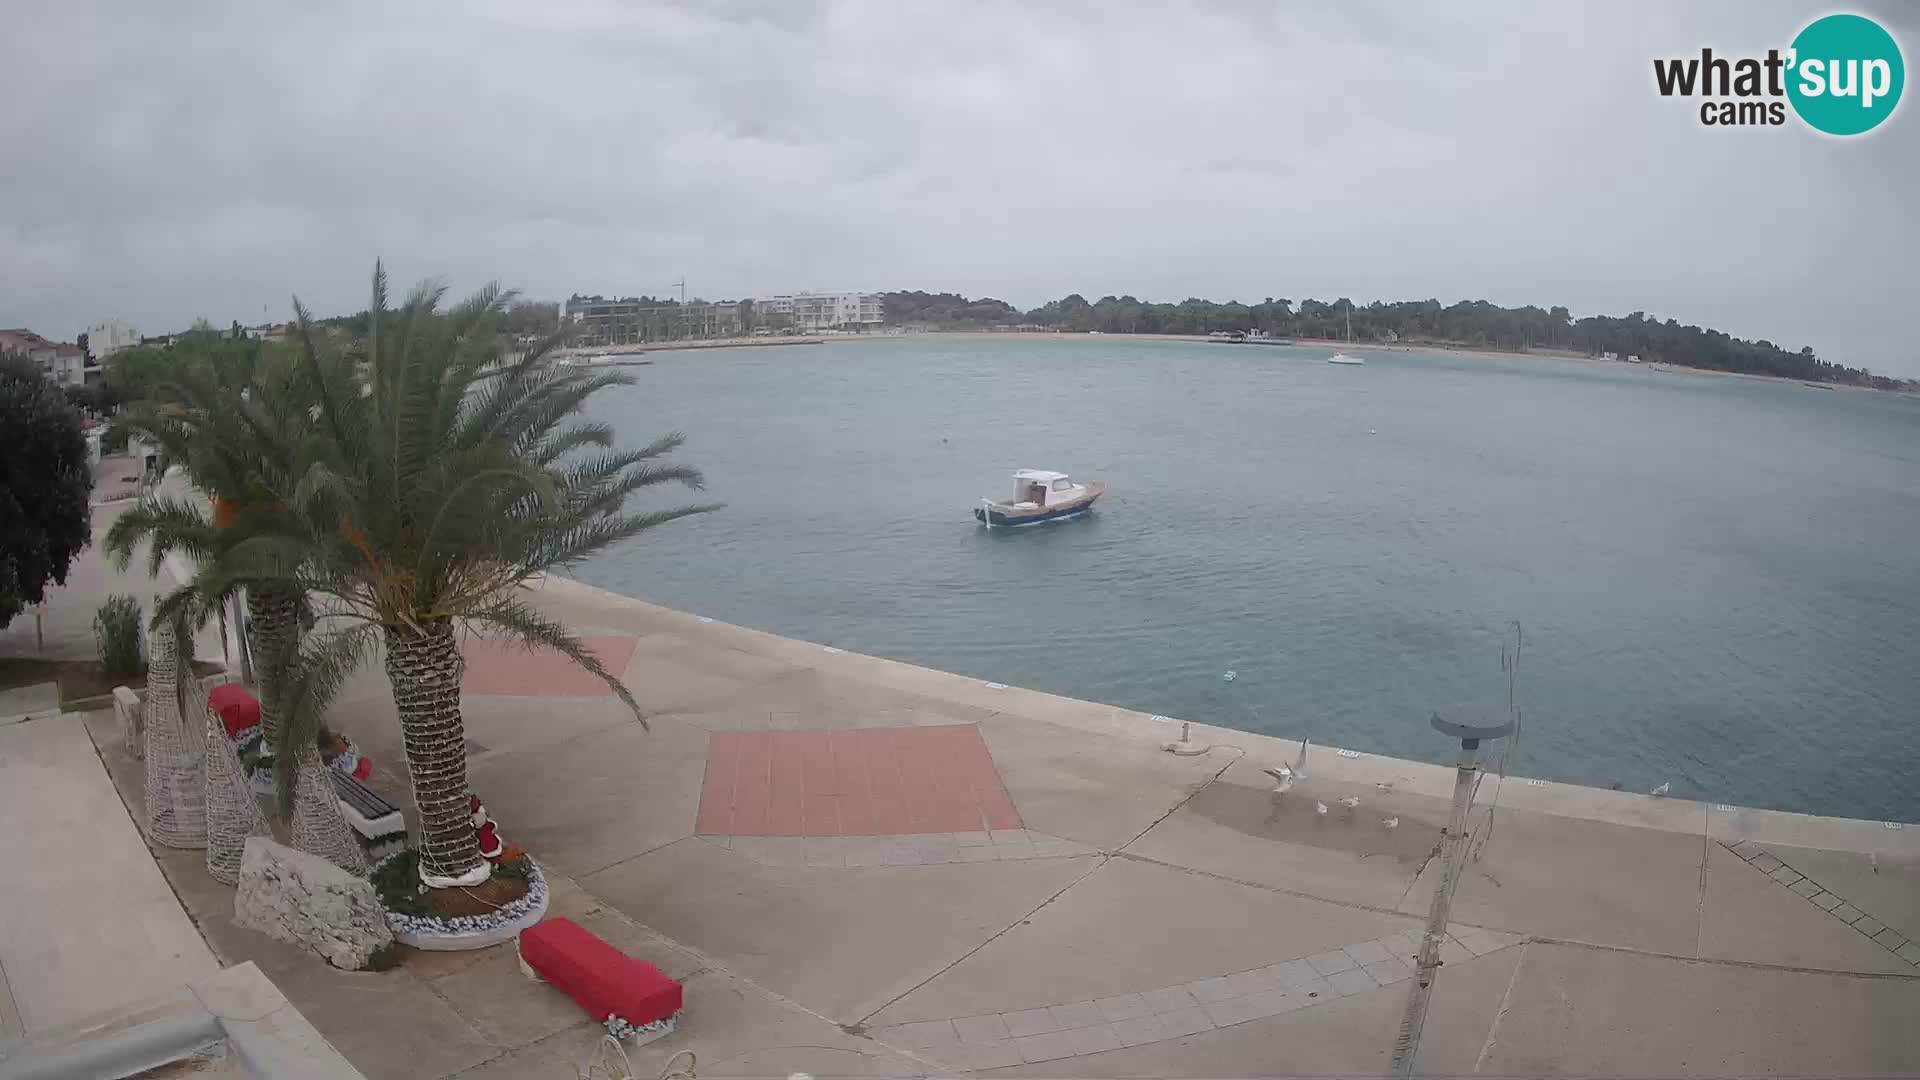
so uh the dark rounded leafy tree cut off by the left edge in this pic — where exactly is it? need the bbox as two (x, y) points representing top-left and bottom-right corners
(0, 356), (94, 626)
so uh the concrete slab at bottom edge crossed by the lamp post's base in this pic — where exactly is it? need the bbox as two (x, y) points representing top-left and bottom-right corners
(987, 937), (1521, 1078)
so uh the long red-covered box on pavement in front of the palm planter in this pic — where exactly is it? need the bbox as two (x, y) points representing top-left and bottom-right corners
(520, 917), (684, 1043)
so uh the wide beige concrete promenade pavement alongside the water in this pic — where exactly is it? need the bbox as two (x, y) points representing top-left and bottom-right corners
(71, 578), (1920, 1078)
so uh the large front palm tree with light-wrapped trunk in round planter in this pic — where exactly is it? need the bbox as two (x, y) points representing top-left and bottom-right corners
(189, 265), (718, 888)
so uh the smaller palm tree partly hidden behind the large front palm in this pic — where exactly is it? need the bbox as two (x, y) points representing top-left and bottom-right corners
(106, 331), (365, 871)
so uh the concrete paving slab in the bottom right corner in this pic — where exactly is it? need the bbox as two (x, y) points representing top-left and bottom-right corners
(1482, 944), (1920, 1076)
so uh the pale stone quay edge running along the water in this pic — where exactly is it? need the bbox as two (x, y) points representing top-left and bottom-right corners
(532, 575), (1920, 857)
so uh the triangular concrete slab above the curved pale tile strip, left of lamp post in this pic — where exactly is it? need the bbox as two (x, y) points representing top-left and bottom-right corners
(874, 859), (1413, 1024)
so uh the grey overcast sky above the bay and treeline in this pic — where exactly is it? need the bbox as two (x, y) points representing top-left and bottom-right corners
(0, 0), (1920, 377)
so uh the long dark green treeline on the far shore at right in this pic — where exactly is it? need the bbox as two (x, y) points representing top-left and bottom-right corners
(885, 292), (1893, 388)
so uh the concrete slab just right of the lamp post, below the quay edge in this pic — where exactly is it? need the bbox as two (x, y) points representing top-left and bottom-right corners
(1402, 807), (1709, 955)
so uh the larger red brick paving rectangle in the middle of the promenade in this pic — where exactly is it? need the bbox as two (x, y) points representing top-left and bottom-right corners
(695, 724), (1021, 836)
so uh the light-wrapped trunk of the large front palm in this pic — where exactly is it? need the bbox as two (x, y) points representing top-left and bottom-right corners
(386, 621), (488, 884)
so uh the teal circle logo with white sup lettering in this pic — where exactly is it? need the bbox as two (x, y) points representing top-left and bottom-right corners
(1788, 15), (1907, 135)
